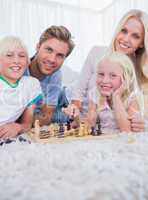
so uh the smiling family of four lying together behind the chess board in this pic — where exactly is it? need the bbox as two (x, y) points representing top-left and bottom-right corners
(0, 10), (148, 140)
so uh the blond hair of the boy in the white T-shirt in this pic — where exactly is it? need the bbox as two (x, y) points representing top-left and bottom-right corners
(0, 36), (29, 62)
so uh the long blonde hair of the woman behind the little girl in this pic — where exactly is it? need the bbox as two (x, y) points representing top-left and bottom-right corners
(110, 9), (148, 84)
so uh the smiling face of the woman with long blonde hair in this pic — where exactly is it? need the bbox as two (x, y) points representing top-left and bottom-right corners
(114, 17), (144, 55)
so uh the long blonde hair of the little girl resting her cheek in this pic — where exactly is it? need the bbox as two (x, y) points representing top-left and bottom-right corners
(97, 52), (144, 114)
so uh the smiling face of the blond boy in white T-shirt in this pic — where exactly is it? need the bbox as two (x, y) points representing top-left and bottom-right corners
(0, 48), (28, 83)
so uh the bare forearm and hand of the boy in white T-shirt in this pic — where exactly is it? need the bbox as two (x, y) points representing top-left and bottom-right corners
(0, 105), (35, 139)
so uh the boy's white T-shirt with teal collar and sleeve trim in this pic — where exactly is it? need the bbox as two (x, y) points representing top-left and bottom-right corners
(0, 76), (42, 125)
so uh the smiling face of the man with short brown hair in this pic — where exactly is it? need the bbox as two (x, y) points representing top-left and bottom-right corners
(36, 38), (69, 75)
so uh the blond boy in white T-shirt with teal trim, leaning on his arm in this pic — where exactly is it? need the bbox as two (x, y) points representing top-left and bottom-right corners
(0, 36), (42, 139)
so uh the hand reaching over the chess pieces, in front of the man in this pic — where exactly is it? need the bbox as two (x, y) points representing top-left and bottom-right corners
(62, 104), (80, 118)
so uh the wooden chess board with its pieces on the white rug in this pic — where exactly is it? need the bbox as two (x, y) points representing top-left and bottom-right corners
(28, 121), (118, 144)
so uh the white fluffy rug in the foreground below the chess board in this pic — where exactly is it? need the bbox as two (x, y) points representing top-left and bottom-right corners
(0, 133), (148, 200)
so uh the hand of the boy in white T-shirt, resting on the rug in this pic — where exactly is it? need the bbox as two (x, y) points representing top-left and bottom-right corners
(0, 123), (21, 139)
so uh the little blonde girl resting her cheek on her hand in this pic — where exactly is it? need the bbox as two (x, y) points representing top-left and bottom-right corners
(94, 52), (143, 132)
